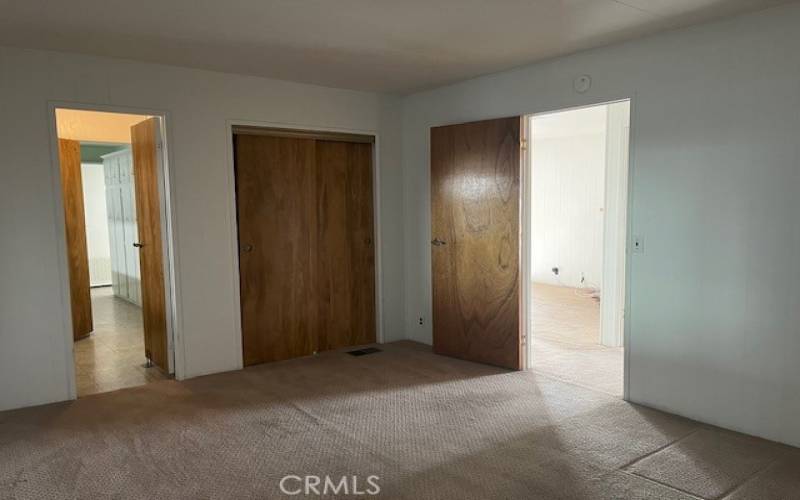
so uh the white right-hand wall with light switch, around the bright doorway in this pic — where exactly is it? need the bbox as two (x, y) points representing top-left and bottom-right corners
(403, 4), (800, 445)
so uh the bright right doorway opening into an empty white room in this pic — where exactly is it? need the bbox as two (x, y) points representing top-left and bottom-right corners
(524, 100), (630, 397)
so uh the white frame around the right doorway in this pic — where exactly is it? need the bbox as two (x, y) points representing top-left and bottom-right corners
(520, 98), (635, 401)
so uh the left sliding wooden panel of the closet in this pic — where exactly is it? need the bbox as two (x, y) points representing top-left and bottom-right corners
(234, 135), (318, 365)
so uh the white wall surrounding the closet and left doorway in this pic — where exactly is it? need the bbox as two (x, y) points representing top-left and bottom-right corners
(0, 48), (403, 409)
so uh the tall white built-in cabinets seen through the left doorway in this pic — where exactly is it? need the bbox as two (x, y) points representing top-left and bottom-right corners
(103, 149), (142, 306)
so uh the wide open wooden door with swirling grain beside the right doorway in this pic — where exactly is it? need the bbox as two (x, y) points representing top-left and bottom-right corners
(430, 117), (522, 369)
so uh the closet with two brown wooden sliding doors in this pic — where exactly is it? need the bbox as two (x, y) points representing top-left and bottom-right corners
(233, 127), (376, 365)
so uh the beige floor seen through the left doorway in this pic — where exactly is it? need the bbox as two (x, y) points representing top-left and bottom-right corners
(73, 287), (168, 397)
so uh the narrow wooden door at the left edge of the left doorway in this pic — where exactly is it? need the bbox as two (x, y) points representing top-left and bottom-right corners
(58, 139), (94, 340)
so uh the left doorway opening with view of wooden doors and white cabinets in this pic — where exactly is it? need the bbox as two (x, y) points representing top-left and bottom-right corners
(55, 107), (174, 397)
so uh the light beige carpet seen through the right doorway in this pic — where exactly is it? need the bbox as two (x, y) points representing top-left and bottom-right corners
(531, 283), (624, 398)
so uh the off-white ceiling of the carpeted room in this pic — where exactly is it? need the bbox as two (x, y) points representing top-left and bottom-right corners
(0, 0), (789, 93)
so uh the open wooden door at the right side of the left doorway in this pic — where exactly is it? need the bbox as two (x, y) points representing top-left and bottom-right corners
(131, 118), (169, 372)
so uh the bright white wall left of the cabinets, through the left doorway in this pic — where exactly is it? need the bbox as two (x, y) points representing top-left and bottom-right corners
(81, 163), (111, 286)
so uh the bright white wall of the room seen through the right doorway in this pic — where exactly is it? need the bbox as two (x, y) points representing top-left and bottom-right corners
(529, 106), (608, 289)
